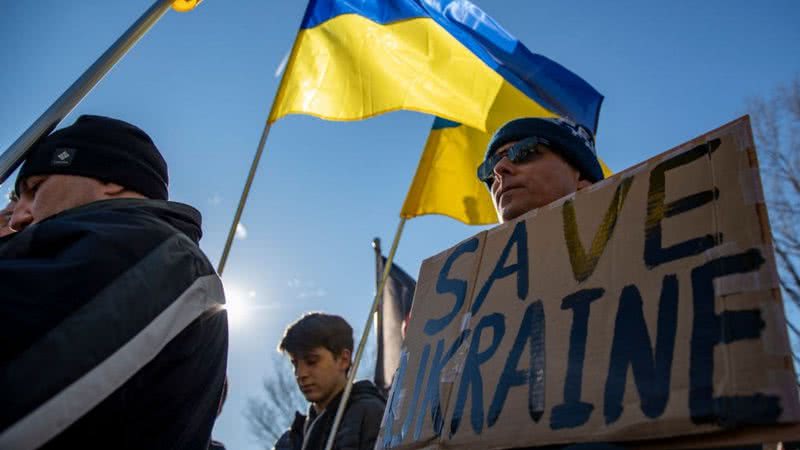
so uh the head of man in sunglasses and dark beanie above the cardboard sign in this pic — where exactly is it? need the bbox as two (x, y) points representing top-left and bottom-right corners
(478, 118), (603, 223)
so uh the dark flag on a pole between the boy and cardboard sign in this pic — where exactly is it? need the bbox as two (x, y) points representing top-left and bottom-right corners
(373, 238), (417, 392)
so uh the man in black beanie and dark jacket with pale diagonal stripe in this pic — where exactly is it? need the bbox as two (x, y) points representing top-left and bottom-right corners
(0, 116), (228, 449)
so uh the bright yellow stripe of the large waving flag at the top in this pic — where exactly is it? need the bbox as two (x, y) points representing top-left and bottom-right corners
(269, 14), (555, 130)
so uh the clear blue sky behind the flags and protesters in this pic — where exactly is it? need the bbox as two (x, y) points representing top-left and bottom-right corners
(0, 0), (800, 449)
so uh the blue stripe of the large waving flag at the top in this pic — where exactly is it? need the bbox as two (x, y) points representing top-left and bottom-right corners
(301, 0), (603, 132)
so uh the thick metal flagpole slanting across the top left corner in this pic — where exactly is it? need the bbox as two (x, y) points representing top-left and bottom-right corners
(0, 0), (175, 184)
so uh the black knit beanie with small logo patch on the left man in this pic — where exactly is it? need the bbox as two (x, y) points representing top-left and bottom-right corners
(15, 116), (169, 200)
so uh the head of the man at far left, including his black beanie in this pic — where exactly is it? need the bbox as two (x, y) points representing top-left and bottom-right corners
(9, 116), (169, 230)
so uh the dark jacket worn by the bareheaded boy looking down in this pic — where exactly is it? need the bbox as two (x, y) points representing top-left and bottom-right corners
(274, 380), (386, 450)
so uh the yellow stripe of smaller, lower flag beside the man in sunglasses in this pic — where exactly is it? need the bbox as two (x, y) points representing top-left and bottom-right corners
(400, 125), (497, 225)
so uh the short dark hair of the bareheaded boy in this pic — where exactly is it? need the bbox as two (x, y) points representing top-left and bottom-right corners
(278, 312), (353, 357)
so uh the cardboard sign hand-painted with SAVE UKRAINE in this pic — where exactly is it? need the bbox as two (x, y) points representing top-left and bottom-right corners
(377, 117), (800, 449)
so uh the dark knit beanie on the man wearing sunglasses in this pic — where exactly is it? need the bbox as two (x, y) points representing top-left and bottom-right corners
(486, 117), (603, 183)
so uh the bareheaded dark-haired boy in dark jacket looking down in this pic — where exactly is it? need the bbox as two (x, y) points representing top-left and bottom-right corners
(275, 312), (386, 450)
